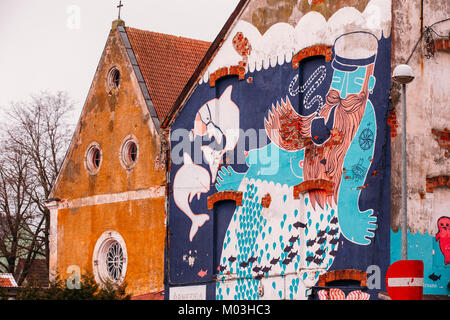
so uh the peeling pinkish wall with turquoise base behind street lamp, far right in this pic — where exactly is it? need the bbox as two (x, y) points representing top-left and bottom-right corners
(391, 0), (450, 294)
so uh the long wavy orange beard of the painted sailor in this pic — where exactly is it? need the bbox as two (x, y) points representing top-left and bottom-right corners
(264, 85), (368, 208)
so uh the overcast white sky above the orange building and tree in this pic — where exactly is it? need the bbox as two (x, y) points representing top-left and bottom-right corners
(0, 0), (239, 118)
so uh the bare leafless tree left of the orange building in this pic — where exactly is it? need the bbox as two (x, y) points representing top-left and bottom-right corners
(0, 92), (73, 285)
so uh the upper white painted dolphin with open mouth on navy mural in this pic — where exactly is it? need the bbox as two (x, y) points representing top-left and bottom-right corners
(190, 85), (239, 182)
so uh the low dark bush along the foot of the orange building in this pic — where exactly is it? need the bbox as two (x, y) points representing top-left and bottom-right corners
(16, 273), (131, 300)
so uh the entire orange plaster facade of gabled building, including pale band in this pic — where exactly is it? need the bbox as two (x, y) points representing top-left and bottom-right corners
(52, 28), (165, 295)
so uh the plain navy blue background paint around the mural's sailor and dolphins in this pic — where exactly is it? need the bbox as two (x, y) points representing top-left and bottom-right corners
(166, 38), (391, 299)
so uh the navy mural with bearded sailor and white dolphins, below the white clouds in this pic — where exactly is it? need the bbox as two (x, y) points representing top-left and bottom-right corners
(168, 0), (390, 299)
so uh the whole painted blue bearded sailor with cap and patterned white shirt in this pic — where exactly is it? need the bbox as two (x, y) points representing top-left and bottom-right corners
(211, 33), (378, 299)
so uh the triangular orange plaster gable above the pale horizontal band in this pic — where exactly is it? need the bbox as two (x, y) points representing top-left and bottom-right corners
(53, 31), (165, 199)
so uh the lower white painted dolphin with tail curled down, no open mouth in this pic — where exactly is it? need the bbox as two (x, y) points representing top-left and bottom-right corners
(173, 153), (210, 242)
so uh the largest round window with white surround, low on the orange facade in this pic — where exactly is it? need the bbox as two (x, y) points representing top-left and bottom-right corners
(93, 230), (127, 284)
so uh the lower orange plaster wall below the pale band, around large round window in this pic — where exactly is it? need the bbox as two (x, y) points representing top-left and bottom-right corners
(57, 197), (165, 295)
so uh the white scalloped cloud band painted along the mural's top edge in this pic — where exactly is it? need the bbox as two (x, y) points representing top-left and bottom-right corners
(200, 0), (391, 83)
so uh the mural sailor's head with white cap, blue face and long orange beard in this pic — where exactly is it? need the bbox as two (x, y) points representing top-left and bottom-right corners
(265, 33), (378, 208)
